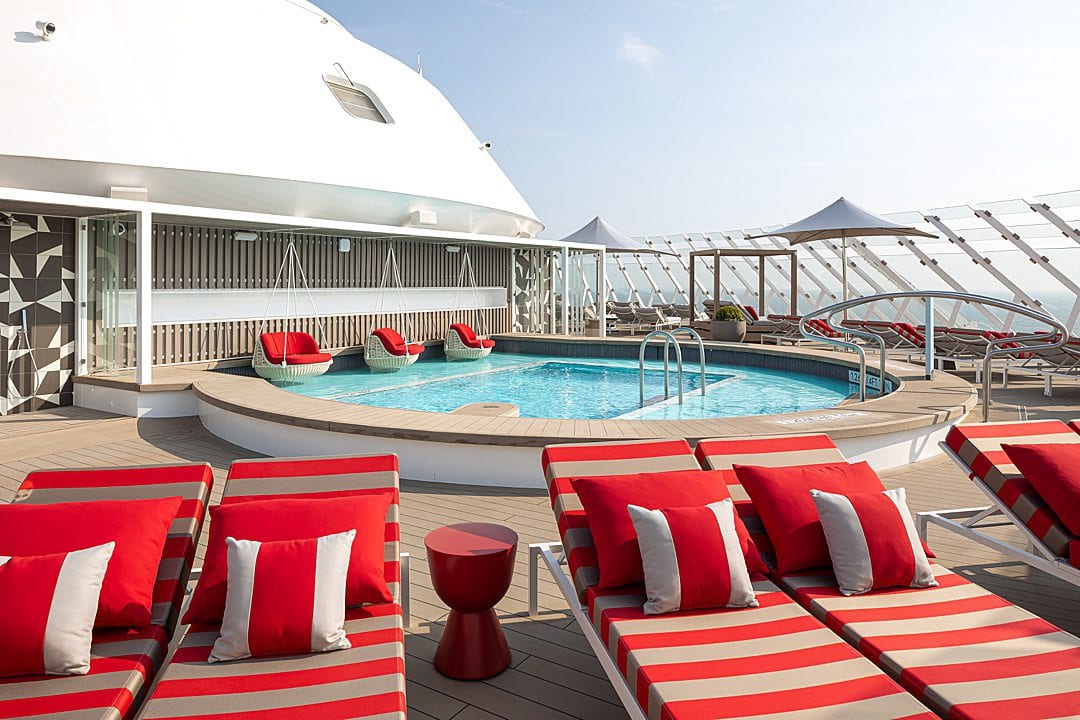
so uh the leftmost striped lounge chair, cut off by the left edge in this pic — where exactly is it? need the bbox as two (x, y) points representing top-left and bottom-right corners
(0, 463), (214, 720)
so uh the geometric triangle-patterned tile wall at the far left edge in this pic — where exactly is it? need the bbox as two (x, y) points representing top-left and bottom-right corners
(0, 215), (76, 415)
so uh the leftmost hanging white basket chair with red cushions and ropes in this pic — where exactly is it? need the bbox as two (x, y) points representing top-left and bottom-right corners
(252, 240), (334, 382)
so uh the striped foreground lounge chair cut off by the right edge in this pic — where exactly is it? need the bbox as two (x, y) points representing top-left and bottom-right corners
(918, 420), (1080, 587)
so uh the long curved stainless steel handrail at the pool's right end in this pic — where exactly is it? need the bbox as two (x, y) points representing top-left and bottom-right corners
(799, 290), (1069, 422)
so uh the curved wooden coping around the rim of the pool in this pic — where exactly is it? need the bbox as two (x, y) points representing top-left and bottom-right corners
(76, 335), (977, 447)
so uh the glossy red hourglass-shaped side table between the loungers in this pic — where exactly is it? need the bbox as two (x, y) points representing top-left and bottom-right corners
(423, 522), (517, 680)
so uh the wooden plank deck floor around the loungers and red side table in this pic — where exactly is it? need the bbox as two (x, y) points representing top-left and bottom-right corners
(0, 375), (1080, 720)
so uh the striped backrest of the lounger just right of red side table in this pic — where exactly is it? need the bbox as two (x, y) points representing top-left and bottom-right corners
(541, 439), (701, 601)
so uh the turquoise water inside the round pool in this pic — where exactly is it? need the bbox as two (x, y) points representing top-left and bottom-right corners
(274, 353), (849, 420)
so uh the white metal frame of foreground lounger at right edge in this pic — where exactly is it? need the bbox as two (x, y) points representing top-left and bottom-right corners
(915, 443), (1080, 587)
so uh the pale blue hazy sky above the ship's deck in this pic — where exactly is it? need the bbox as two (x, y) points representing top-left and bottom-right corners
(316, 0), (1080, 237)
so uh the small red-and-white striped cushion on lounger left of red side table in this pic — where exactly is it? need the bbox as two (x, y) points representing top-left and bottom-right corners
(208, 530), (356, 663)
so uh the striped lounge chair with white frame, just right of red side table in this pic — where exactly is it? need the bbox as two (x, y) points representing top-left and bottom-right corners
(529, 439), (934, 720)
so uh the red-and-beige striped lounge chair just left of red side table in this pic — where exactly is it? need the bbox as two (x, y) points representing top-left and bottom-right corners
(135, 456), (408, 720)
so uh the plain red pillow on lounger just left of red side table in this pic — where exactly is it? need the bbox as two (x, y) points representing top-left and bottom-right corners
(184, 492), (393, 625)
